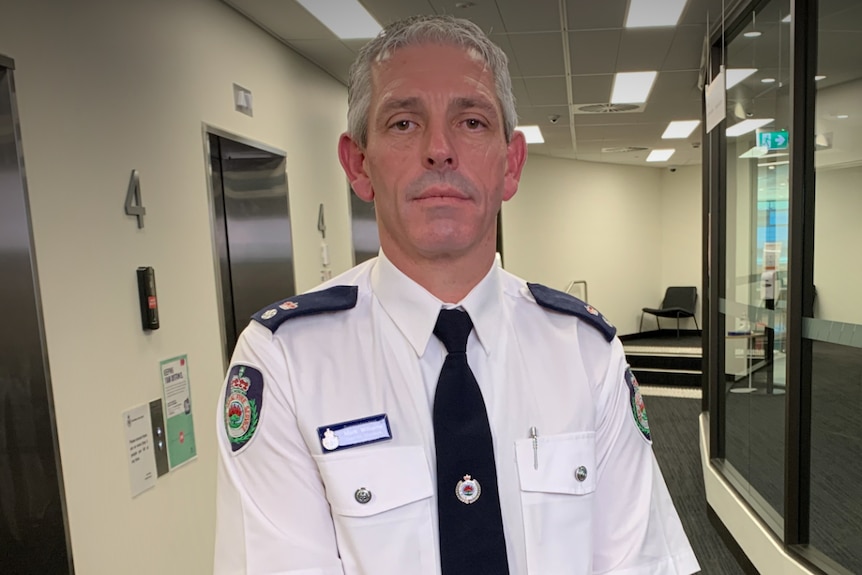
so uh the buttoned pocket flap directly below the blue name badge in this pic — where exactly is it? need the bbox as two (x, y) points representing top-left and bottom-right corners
(314, 446), (434, 517)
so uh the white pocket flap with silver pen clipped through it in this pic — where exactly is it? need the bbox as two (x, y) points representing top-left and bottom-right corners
(515, 431), (598, 495)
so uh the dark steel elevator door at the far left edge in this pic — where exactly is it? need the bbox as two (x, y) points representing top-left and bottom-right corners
(0, 56), (73, 575)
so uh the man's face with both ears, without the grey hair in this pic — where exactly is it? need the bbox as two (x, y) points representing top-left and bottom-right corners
(339, 44), (526, 262)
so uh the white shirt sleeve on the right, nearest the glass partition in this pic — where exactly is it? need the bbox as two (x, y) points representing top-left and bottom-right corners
(593, 339), (700, 575)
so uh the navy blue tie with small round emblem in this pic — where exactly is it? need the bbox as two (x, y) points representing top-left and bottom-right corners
(434, 309), (509, 575)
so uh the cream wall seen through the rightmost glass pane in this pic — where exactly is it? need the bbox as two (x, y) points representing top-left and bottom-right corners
(814, 166), (862, 324)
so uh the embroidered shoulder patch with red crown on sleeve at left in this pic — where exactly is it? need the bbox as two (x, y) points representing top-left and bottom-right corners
(224, 364), (263, 453)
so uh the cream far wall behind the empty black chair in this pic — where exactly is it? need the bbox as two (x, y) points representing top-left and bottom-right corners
(502, 155), (672, 334)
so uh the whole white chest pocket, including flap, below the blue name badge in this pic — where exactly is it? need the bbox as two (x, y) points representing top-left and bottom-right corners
(314, 446), (436, 575)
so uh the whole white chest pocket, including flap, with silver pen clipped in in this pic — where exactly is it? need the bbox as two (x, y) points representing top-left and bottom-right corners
(515, 431), (598, 575)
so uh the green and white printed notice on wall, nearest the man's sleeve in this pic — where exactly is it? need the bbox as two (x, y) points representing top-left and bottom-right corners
(159, 355), (197, 469)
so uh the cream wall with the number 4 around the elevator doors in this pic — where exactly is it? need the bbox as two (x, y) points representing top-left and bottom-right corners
(0, 0), (351, 575)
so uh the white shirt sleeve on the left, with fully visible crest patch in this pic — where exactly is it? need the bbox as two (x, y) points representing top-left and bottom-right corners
(213, 322), (343, 575)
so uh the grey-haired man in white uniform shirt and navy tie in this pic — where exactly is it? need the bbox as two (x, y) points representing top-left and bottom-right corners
(215, 16), (698, 575)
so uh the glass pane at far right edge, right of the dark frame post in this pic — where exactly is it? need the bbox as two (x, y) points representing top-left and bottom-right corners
(803, 0), (862, 573)
